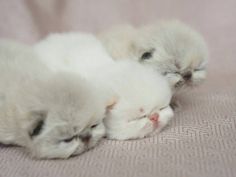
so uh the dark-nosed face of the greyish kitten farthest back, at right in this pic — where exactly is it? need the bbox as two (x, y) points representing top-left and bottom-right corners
(139, 48), (206, 91)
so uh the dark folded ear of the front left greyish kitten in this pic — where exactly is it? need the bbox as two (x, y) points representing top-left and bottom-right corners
(28, 110), (48, 138)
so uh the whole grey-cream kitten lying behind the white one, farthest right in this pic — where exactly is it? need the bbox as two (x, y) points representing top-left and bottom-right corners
(100, 21), (208, 92)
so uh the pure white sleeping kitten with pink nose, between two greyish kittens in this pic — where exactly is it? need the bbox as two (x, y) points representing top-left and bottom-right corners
(35, 33), (173, 140)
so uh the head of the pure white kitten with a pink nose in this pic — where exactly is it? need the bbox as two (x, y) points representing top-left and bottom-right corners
(105, 61), (173, 139)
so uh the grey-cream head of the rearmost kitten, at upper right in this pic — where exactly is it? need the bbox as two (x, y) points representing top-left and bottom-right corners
(133, 21), (208, 91)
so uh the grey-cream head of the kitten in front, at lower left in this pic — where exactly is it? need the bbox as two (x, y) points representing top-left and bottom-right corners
(24, 74), (106, 158)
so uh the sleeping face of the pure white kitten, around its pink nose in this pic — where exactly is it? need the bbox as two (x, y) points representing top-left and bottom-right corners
(105, 97), (174, 140)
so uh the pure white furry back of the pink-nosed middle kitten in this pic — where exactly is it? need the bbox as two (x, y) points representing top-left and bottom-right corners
(34, 33), (111, 75)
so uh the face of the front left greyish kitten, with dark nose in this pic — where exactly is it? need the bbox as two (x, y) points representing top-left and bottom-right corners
(26, 107), (105, 158)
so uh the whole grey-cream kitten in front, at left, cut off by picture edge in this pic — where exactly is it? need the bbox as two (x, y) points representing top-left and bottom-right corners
(0, 41), (105, 158)
